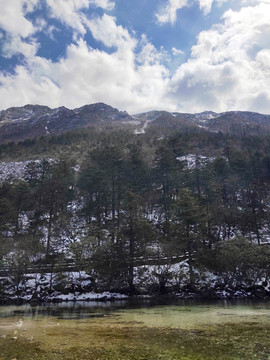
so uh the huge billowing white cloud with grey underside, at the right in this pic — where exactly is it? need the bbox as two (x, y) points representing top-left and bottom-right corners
(171, 2), (270, 112)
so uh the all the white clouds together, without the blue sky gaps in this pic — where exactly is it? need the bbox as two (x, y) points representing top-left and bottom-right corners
(0, 0), (270, 113)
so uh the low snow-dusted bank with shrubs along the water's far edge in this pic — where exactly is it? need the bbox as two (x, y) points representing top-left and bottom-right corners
(0, 268), (270, 304)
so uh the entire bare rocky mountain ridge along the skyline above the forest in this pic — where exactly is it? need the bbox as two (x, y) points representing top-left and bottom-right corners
(0, 103), (270, 144)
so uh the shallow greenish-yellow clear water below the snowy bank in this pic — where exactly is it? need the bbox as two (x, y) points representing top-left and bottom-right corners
(0, 303), (270, 360)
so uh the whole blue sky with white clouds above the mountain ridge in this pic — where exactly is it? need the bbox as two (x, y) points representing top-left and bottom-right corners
(0, 0), (270, 114)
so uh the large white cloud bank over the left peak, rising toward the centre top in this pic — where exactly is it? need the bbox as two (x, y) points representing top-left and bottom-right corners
(0, 15), (169, 112)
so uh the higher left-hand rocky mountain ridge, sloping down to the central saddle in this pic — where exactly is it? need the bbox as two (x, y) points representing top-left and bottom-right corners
(0, 103), (133, 144)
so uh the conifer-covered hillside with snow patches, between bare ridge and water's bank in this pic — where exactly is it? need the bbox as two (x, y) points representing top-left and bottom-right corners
(0, 109), (270, 296)
